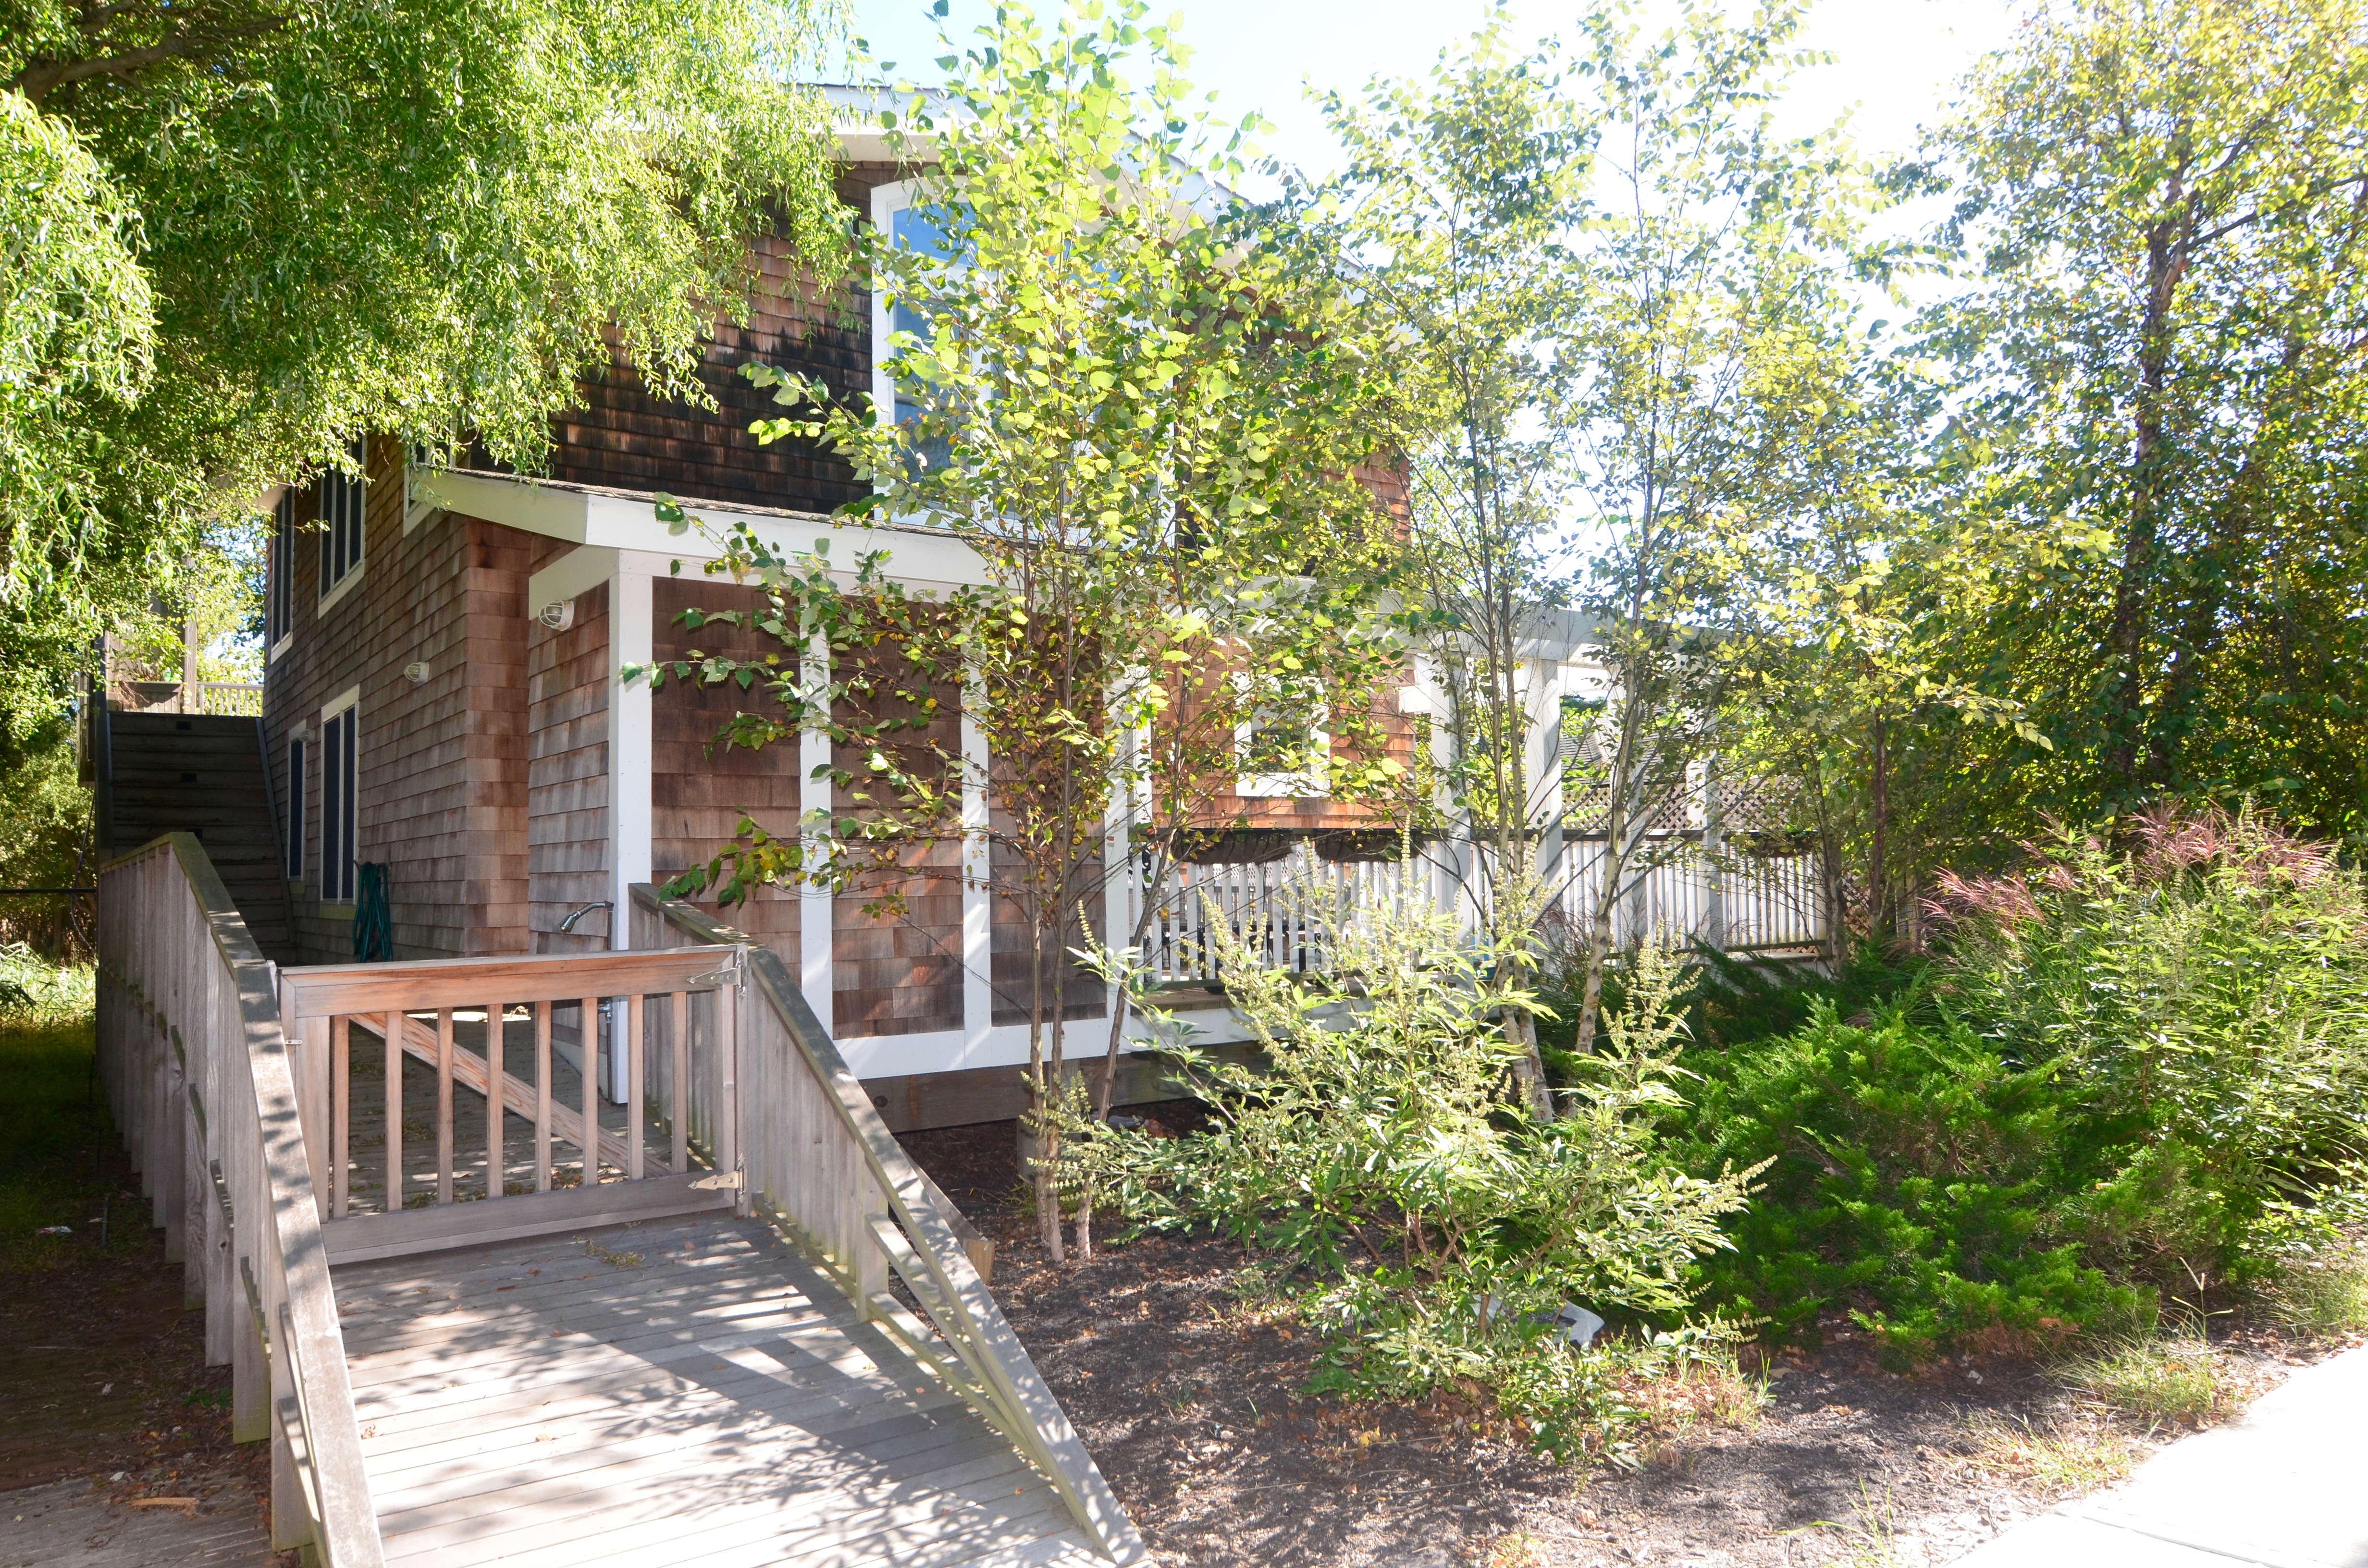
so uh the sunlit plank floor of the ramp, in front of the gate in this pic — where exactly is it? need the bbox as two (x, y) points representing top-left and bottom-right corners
(332, 1215), (1103, 1568)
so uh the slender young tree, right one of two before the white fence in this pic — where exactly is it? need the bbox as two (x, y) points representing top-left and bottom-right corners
(1558, 5), (1863, 1052)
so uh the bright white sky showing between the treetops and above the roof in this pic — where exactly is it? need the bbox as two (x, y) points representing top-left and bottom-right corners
(855, 0), (2013, 186)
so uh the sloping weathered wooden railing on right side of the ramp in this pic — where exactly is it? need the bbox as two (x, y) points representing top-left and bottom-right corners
(632, 883), (1148, 1563)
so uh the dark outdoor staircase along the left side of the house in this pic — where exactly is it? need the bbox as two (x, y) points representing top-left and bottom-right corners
(97, 713), (296, 964)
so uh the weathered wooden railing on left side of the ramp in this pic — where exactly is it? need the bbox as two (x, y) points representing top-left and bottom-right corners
(99, 834), (383, 1568)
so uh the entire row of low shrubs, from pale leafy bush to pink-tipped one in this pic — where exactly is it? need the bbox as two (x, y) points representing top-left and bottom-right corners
(1087, 812), (2368, 1452)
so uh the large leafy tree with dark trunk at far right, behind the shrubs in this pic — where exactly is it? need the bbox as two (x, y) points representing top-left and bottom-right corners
(1930, 0), (2368, 834)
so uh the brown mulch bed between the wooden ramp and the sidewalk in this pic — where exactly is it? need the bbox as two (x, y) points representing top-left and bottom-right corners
(902, 1123), (2330, 1568)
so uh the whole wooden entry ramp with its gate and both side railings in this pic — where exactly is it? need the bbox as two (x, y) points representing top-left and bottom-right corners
(83, 834), (1146, 1568)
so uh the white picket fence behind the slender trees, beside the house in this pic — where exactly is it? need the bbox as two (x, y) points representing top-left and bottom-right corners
(1135, 838), (1825, 980)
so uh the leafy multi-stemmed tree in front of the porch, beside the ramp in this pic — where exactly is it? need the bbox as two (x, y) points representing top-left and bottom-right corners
(649, 5), (1390, 1258)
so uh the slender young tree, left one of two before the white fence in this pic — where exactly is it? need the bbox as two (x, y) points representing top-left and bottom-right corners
(1324, 31), (1591, 1115)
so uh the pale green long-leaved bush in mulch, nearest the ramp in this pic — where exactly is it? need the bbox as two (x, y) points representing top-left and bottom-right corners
(1082, 900), (1750, 1454)
